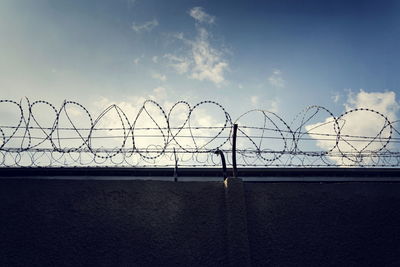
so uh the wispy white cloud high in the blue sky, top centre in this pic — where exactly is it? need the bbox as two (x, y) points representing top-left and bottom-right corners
(164, 8), (229, 86)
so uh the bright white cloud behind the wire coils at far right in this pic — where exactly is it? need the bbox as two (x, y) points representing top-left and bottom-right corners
(305, 90), (400, 165)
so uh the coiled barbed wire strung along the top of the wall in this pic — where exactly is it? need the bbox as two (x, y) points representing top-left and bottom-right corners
(0, 99), (400, 167)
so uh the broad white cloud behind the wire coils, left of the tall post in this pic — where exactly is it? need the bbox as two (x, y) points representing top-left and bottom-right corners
(93, 87), (230, 164)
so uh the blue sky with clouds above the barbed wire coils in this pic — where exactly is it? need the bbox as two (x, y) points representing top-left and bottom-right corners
(0, 0), (400, 165)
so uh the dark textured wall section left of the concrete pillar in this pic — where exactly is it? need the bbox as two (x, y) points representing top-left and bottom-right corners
(0, 179), (227, 267)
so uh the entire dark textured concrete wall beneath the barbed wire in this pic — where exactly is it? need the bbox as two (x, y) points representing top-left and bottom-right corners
(0, 179), (400, 267)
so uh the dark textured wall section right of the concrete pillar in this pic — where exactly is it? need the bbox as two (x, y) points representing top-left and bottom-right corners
(244, 183), (400, 266)
